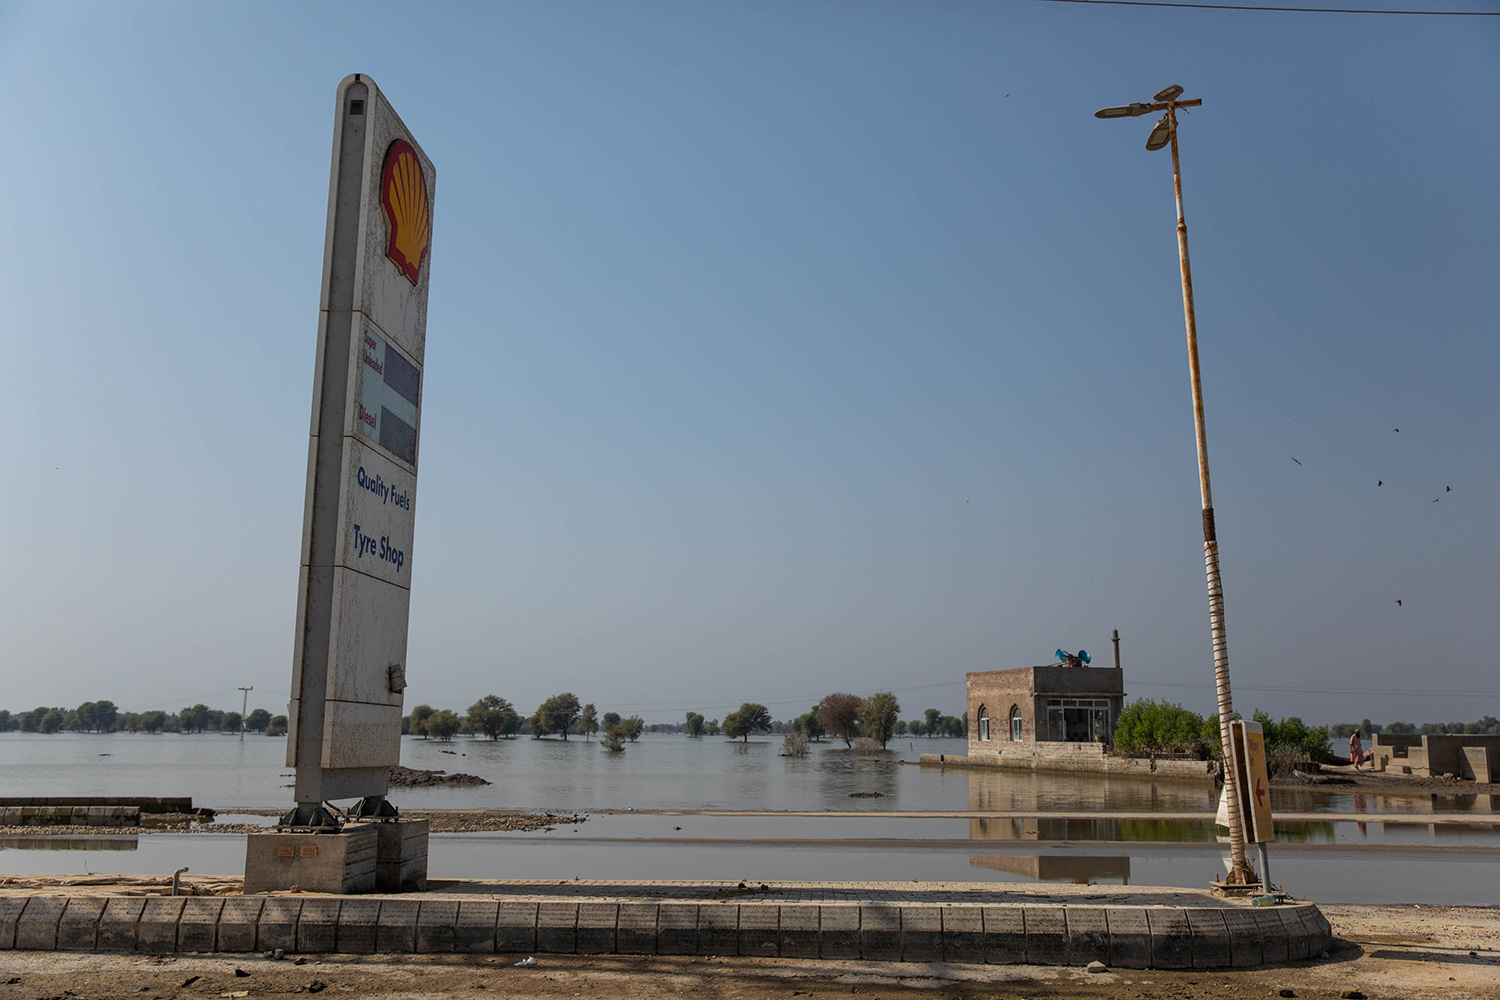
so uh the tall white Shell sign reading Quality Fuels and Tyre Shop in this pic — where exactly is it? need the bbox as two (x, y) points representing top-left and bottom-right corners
(284, 73), (437, 828)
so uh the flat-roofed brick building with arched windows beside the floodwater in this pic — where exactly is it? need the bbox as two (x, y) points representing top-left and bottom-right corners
(966, 664), (1125, 757)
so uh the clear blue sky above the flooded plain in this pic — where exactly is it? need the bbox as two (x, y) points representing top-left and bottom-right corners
(0, 0), (1500, 721)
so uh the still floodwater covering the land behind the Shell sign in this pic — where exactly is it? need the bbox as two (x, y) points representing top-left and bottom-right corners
(0, 733), (1500, 904)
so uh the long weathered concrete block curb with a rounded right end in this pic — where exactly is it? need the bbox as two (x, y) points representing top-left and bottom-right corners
(0, 895), (1334, 969)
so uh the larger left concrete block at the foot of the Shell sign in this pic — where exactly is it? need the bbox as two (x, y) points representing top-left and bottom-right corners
(245, 823), (378, 894)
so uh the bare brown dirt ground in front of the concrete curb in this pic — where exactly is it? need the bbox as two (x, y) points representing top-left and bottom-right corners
(0, 906), (1500, 1000)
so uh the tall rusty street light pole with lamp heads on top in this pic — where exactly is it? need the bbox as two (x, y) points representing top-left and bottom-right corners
(1095, 85), (1269, 892)
